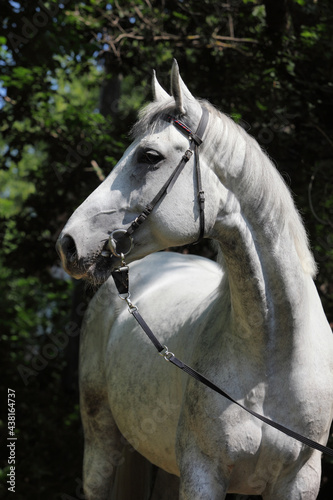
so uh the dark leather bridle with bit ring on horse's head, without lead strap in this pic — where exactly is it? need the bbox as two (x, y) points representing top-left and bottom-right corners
(108, 108), (209, 257)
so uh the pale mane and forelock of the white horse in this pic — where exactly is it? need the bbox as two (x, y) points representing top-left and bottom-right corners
(131, 97), (317, 277)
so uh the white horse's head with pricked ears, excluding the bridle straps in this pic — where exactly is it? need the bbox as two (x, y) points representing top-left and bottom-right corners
(57, 61), (221, 282)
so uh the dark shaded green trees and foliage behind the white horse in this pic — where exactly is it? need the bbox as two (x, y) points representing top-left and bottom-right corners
(0, 0), (333, 500)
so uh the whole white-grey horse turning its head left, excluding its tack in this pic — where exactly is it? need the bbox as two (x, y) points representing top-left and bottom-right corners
(58, 63), (333, 500)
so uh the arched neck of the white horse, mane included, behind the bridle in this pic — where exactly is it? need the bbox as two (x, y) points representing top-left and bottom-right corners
(211, 114), (314, 342)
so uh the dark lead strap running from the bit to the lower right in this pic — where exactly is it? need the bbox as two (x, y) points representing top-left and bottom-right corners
(112, 264), (333, 457)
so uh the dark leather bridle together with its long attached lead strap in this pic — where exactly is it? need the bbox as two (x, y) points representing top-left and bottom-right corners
(108, 108), (333, 457)
